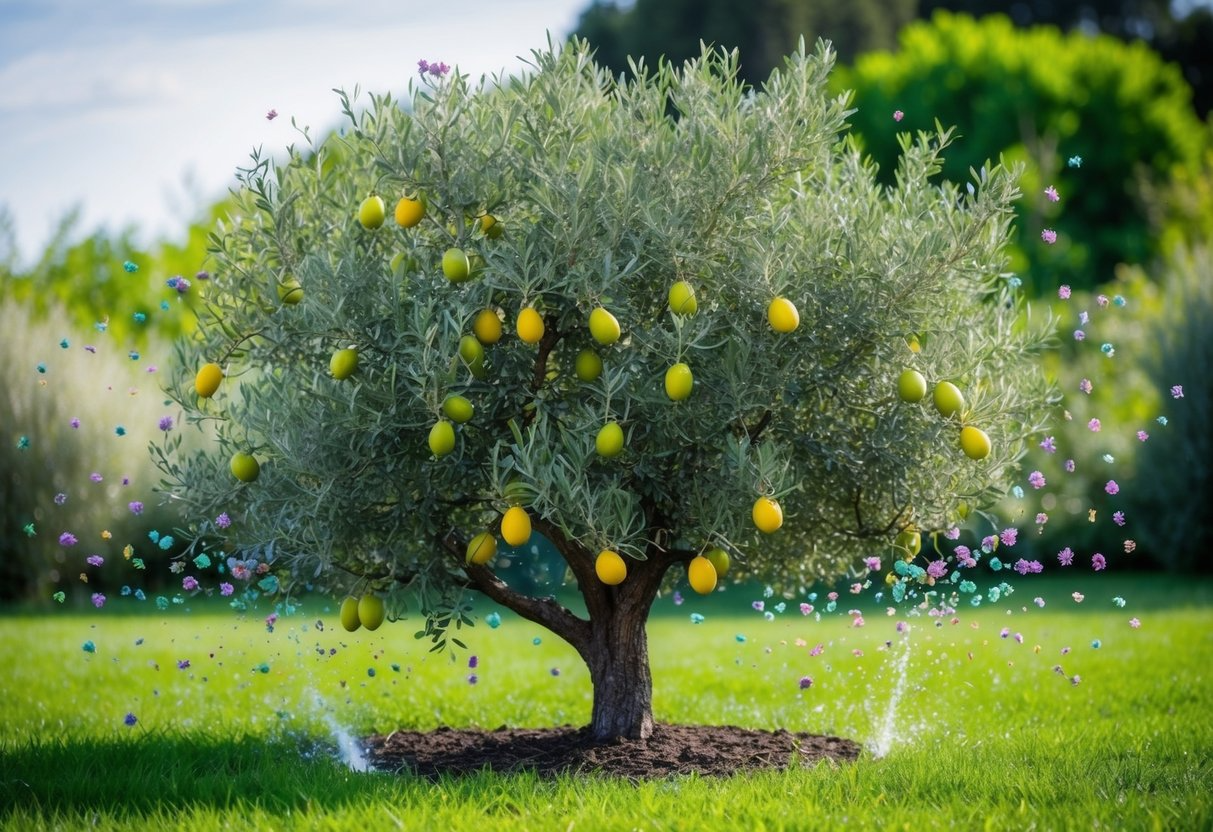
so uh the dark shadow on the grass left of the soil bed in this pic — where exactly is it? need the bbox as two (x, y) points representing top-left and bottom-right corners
(0, 729), (388, 826)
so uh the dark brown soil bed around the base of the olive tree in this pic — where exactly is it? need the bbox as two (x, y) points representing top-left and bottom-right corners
(365, 725), (860, 780)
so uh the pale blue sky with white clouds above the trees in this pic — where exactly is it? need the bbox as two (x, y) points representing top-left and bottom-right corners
(0, 0), (588, 263)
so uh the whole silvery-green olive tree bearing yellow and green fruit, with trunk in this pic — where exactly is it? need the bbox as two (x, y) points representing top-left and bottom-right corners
(160, 44), (1047, 739)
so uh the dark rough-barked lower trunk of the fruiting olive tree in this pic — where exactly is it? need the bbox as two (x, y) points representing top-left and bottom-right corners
(583, 605), (653, 742)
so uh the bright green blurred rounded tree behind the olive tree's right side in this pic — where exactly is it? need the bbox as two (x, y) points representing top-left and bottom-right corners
(833, 12), (1208, 292)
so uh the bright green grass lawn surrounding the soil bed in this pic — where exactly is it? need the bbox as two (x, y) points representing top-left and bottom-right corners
(0, 575), (1213, 832)
